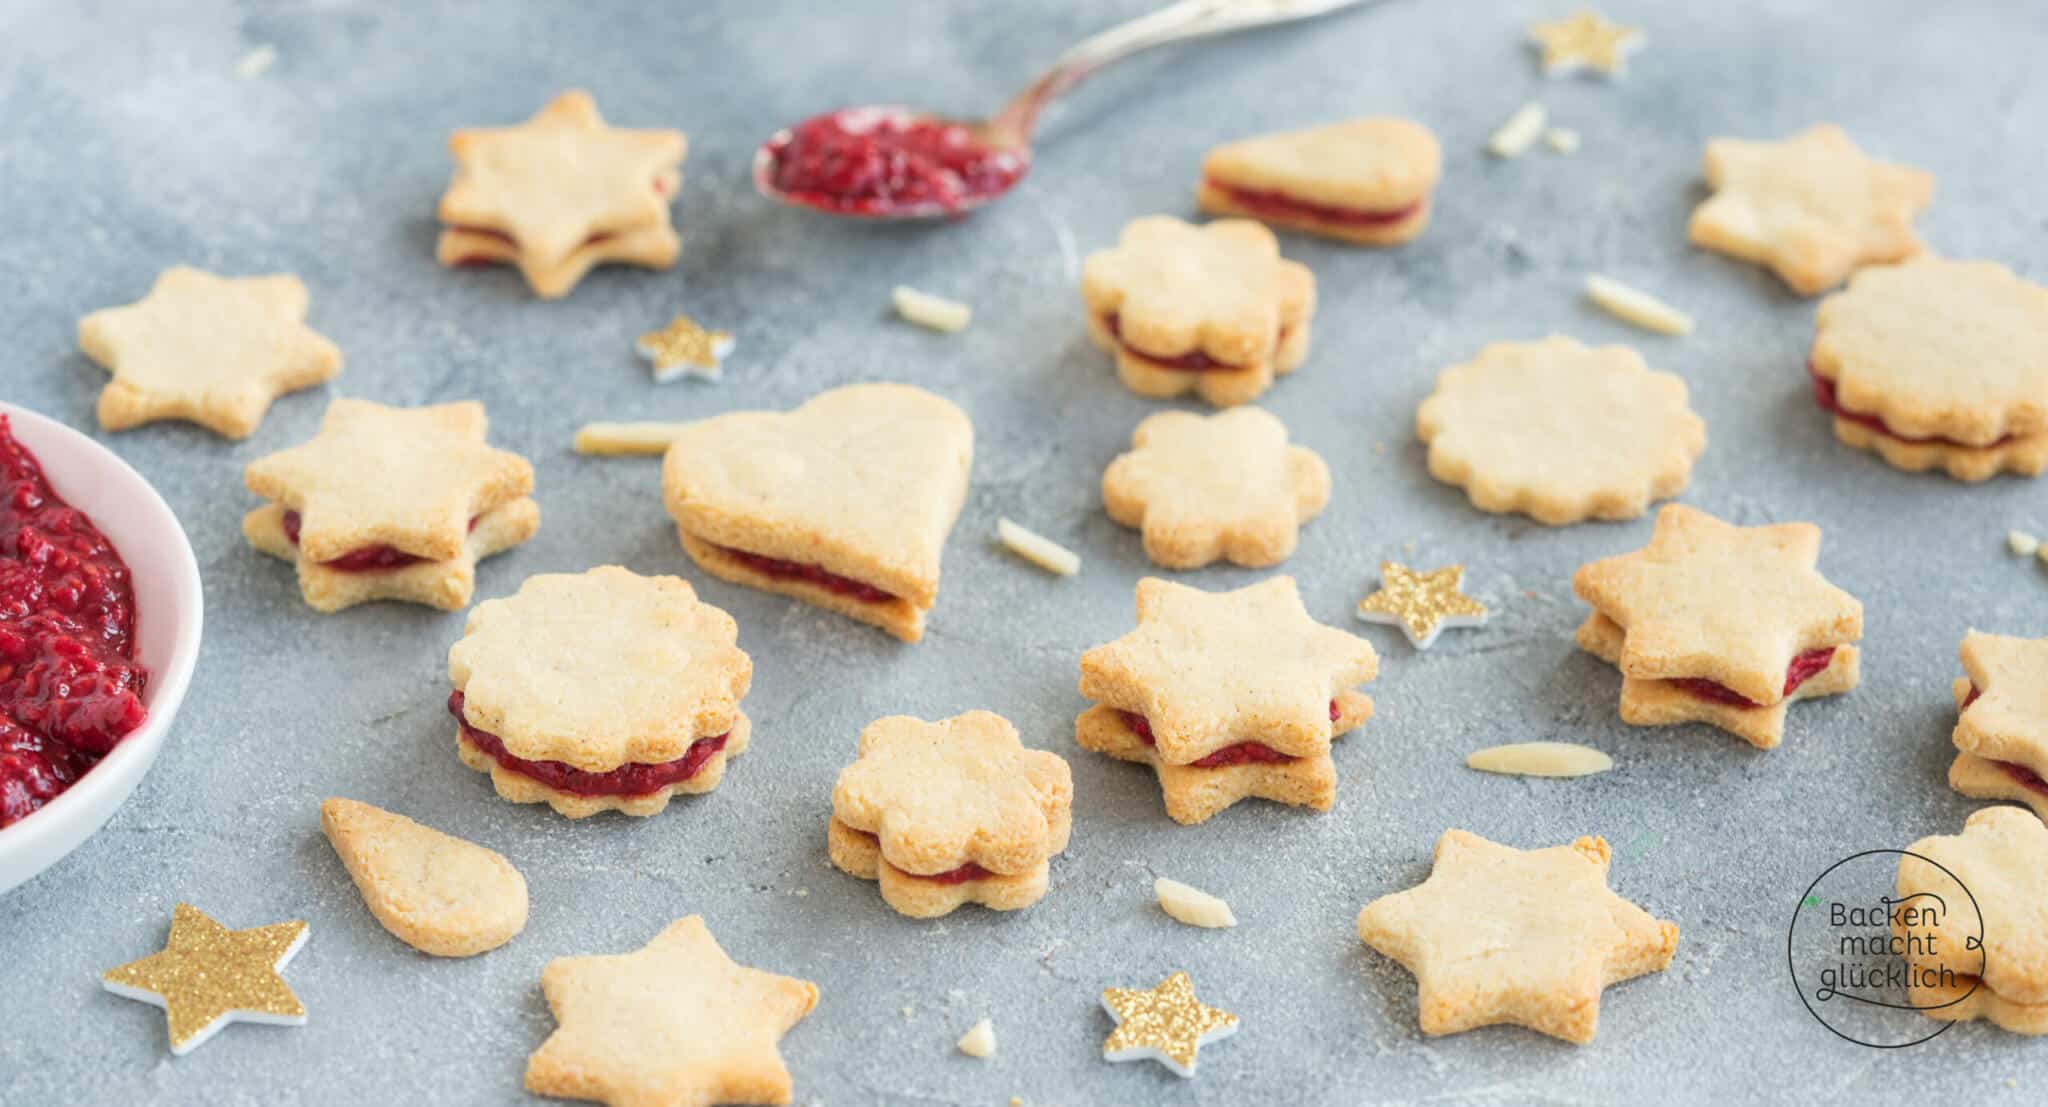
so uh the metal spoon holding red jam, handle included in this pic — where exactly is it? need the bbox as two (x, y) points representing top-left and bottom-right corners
(754, 0), (1366, 219)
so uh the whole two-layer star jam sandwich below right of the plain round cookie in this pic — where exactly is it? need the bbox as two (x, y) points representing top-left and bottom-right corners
(1571, 503), (1864, 749)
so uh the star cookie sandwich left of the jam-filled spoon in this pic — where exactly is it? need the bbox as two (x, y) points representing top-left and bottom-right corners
(436, 90), (688, 299)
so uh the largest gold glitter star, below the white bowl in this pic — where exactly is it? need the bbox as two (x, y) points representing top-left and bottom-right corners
(100, 902), (307, 1054)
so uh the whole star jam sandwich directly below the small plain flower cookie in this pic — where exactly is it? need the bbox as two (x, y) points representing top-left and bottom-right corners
(1075, 577), (1378, 825)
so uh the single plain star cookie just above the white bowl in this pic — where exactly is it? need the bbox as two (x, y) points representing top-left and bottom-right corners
(78, 266), (342, 438)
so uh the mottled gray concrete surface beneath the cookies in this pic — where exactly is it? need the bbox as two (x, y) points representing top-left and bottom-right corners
(0, 0), (2048, 1107)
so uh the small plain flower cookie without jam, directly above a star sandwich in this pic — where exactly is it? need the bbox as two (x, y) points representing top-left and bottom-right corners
(1102, 407), (1329, 569)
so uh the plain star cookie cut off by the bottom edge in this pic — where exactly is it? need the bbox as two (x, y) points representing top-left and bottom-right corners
(526, 915), (817, 1107)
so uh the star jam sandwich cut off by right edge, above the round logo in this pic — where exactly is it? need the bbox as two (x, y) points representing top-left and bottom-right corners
(1948, 630), (2048, 818)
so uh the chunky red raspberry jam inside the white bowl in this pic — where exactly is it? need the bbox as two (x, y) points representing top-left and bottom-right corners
(0, 415), (150, 827)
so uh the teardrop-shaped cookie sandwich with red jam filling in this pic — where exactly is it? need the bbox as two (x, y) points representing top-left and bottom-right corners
(1194, 117), (1444, 246)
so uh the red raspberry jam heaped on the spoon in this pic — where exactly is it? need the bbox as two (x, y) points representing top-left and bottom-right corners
(762, 108), (1030, 217)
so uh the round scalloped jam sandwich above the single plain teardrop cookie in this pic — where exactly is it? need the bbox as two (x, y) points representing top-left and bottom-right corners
(449, 565), (754, 818)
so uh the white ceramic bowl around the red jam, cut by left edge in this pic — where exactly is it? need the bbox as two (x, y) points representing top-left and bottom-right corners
(0, 403), (205, 894)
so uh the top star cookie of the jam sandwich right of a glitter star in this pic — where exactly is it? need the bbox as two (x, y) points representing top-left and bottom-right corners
(1571, 503), (1864, 706)
